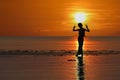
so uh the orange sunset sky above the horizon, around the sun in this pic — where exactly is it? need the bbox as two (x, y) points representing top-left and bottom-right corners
(0, 0), (120, 36)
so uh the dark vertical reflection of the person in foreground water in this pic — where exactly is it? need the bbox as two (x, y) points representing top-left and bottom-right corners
(77, 57), (85, 80)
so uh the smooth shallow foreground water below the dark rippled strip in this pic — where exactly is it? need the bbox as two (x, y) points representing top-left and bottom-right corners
(0, 55), (120, 80)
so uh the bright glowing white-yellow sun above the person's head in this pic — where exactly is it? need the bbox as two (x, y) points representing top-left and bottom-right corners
(74, 12), (86, 23)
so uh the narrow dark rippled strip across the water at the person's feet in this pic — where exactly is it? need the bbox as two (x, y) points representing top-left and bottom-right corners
(0, 50), (120, 56)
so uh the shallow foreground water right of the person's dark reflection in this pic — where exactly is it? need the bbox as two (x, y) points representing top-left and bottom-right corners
(85, 55), (120, 80)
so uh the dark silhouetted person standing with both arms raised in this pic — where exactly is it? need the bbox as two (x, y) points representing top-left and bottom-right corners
(73, 23), (90, 58)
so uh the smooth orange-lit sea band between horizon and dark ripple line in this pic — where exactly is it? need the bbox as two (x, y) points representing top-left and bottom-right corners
(0, 36), (120, 51)
